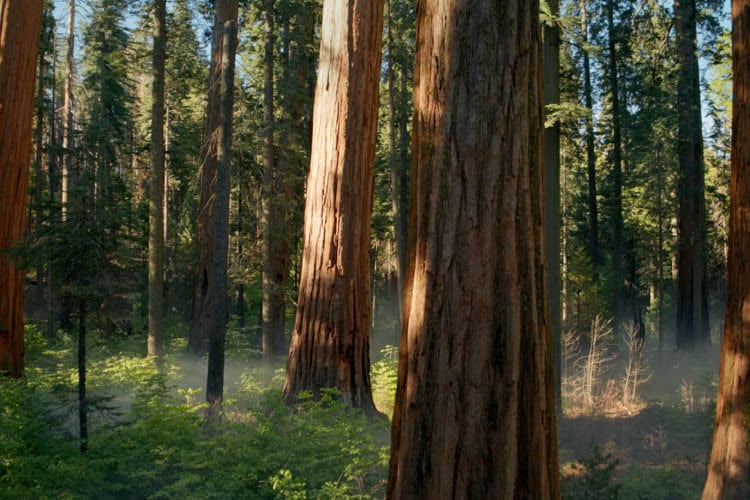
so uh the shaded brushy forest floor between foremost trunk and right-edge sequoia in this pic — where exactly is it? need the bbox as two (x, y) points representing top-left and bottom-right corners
(558, 345), (718, 500)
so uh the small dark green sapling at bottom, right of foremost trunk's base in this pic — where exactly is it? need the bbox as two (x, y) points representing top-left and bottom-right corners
(562, 447), (620, 500)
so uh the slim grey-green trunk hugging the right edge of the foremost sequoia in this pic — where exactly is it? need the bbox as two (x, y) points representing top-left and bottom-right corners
(544, 0), (562, 418)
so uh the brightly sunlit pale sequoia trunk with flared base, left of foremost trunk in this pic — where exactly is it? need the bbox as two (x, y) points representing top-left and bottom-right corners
(284, 0), (383, 414)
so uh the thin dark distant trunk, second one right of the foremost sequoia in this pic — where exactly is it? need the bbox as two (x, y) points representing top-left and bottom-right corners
(581, 0), (599, 281)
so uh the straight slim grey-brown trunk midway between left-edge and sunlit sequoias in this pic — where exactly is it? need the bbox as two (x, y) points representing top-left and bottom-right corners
(148, 0), (167, 358)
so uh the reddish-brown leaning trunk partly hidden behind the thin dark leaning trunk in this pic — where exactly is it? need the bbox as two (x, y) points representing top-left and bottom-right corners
(188, 0), (237, 355)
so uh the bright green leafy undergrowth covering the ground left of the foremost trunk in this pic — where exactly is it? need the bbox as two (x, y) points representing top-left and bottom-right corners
(0, 322), (392, 499)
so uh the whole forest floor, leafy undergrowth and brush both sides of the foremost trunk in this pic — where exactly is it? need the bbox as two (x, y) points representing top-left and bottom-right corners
(0, 314), (718, 500)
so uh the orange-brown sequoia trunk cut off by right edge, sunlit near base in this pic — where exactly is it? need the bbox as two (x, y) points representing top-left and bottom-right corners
(703, 0), (750, 499)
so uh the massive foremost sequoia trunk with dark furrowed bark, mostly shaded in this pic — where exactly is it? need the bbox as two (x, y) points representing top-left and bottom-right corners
(387, 0), (559, 499)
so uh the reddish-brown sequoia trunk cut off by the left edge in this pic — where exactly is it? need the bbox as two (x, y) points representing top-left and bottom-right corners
(0, 0), (42, 377)
